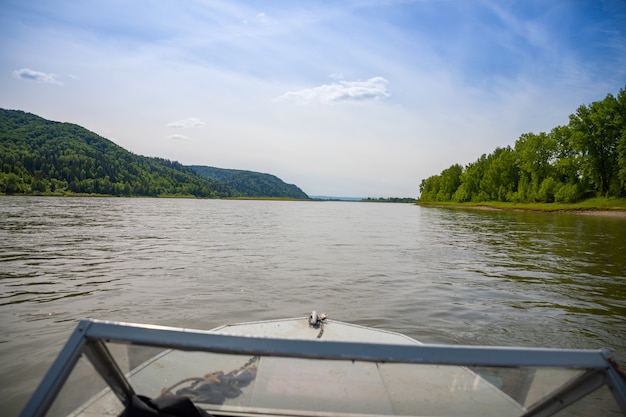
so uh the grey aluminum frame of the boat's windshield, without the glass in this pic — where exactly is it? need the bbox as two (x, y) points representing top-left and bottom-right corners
(20, 319), (626, 417)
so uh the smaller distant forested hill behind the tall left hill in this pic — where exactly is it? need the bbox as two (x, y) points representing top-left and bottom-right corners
(189, 165), (309, 199)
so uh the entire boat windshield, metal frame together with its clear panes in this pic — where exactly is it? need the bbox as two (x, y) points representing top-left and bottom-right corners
(17, 322), (626, 417)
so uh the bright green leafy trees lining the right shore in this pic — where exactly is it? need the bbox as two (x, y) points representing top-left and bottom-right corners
(419, 87), (626, 203)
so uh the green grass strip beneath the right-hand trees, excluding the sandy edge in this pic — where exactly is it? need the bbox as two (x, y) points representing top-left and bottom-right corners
(418, 197), (626, 213)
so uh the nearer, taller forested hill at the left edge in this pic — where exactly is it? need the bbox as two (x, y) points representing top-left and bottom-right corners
(0, 109), (308, 198)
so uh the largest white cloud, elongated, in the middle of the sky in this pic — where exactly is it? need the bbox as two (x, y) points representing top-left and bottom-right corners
(278, 77), (391, 104)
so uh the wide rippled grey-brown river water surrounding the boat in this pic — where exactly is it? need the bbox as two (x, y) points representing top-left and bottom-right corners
(0, 196), (626, 417)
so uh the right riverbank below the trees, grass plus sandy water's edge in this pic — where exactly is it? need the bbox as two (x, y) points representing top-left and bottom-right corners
(418, 198), (626, 218)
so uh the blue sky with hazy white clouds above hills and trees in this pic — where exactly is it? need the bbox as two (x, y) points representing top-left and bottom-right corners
(0, 0), (626, 198)
